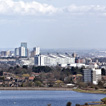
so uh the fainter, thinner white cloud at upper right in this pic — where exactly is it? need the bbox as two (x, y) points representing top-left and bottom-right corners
(63, 5), (106, 15)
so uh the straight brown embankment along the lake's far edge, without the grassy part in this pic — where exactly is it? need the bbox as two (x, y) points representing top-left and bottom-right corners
(0, 87), (73, 91)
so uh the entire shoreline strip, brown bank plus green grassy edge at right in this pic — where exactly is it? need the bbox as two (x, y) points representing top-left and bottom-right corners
(0, 87), (106, 94)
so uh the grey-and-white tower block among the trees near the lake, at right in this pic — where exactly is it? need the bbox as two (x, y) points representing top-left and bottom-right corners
(83, 68), (101, 84)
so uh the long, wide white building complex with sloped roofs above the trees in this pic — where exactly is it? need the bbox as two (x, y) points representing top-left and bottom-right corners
(35, 54), (75, 67)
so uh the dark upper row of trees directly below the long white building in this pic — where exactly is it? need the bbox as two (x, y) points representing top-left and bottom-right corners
(0, 65), (83, 80)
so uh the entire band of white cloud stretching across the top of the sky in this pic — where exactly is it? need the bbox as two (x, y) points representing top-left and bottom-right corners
(0, 0), (106, 16)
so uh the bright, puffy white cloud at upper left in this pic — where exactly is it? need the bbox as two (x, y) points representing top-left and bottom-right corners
(0, 0), (57, 15)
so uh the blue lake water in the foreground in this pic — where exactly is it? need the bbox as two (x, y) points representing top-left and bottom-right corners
(0, 91), (106, 106)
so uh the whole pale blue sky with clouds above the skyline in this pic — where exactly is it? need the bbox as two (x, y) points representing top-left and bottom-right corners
(0, 0), (106, 49)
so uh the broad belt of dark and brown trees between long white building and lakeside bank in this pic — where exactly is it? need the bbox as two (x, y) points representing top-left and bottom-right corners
(0, 65), (83, 87)
